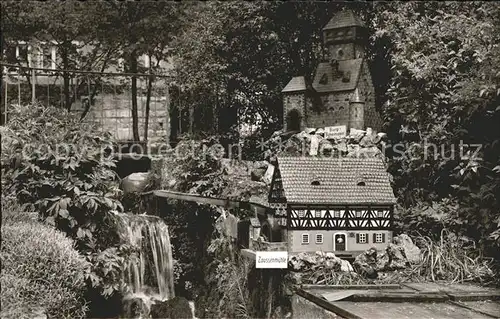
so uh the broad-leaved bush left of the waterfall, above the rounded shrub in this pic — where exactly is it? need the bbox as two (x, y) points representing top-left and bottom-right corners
(1, 105), (122, 249)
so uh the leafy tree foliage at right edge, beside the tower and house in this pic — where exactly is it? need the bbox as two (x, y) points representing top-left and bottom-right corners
(372, 2), (500, 252)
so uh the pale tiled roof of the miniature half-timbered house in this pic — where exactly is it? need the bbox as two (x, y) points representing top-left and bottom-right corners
(278, 157), (396, 205)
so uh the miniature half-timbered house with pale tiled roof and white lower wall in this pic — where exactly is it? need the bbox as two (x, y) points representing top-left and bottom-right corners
(268, 157), (396, 256)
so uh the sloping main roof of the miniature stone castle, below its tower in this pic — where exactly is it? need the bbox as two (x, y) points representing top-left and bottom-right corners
(312, 59), (363, 93)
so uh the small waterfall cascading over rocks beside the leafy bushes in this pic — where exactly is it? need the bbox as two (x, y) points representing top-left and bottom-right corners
(114, 213), (175, 300)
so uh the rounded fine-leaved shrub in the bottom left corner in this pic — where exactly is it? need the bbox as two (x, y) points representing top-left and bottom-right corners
(0, 222), (89, 318)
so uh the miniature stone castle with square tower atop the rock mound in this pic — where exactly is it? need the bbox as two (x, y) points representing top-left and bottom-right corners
(282, 10), (382, 132)
